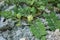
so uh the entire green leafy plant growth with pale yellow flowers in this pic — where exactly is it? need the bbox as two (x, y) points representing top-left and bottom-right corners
(0, 0), (60, 40)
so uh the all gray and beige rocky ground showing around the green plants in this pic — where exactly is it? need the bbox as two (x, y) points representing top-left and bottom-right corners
(0, 1), (60, 40)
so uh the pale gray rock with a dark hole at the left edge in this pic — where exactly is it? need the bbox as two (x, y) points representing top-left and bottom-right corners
(0, 17), (14, 30)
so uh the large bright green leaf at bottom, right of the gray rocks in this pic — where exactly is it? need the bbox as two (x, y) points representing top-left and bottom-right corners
(30, 19), (46, 40)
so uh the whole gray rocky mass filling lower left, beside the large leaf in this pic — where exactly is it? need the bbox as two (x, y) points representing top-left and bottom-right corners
(0, 17), (37, 40)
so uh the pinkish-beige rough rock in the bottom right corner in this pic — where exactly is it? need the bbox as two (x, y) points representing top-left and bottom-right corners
(46, 29), (60, 40)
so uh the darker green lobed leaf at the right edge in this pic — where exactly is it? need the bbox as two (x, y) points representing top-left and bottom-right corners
(43, 12), (60, 31)
